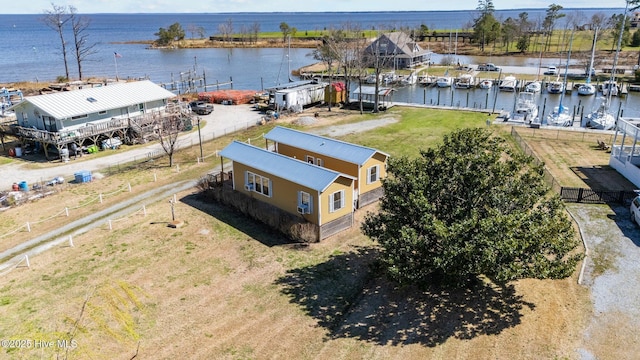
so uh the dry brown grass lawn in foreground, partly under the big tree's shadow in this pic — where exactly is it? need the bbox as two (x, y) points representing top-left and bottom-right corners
(0, 192), (588, 359)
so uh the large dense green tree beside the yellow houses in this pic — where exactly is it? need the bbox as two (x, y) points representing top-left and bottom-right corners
(362, 128), (582, 286)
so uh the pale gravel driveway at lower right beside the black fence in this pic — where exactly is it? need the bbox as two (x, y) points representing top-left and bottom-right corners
(568, 204), (640, 360)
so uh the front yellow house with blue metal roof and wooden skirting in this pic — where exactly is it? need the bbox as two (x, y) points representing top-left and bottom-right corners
(220, 141), (354, 240)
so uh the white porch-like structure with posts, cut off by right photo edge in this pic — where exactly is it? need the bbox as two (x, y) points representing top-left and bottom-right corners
(609, 118), (640, 188)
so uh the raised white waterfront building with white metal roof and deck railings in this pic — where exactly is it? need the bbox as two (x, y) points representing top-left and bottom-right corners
(3, 80), (188, 157)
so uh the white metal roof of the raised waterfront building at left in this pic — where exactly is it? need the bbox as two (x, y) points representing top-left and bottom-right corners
(16, 80), (176, 119)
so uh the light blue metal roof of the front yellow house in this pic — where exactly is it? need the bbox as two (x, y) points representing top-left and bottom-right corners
(220, 141), (353, 192)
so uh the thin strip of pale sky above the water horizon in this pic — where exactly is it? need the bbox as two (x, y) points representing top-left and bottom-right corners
(2, 0), (625, 14)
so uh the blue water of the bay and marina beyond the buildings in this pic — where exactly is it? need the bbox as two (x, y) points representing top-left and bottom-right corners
(0, 9), (640, 116)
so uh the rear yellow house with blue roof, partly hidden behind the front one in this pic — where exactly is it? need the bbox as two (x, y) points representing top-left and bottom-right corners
(265, 126), (389, 208)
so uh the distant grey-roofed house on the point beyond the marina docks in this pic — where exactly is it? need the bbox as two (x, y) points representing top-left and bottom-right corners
(365, 31), (432, 69)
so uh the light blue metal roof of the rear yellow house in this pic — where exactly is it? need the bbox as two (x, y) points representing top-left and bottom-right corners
(264, 126), (388, 165)
